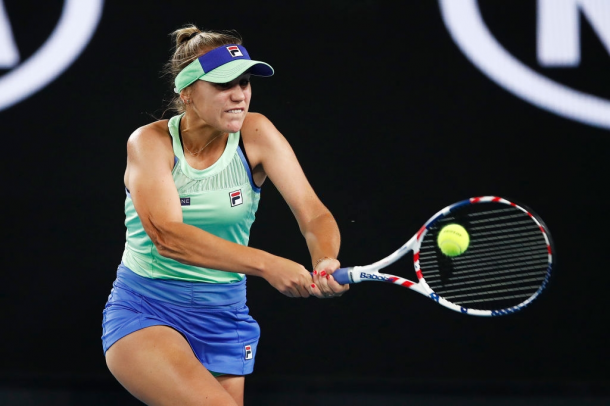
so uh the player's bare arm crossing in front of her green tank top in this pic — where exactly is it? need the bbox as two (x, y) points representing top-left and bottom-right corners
(125, 122), (310, 297)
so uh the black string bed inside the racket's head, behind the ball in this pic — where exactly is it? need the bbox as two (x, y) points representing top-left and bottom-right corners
(419, 203), (551, 310)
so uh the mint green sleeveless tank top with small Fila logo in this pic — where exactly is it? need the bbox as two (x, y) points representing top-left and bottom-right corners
(123, 114), (260, 283)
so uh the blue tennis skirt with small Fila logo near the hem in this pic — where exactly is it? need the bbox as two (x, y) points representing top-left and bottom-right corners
(102, 264), (260, 375)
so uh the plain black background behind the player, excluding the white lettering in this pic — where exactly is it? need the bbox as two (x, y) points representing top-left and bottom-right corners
(0, 0), (610, 406)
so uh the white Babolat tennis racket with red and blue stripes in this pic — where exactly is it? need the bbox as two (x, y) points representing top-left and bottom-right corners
(333, 196), (554, 316)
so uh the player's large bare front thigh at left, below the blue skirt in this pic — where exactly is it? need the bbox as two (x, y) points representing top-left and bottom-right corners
(106, 326), (236, 406)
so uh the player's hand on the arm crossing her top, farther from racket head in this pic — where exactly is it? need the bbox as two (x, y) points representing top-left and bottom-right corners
(263, 257), (315, 297)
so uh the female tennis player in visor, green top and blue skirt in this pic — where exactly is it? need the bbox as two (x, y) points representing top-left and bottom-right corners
(102, 26), (348, 406)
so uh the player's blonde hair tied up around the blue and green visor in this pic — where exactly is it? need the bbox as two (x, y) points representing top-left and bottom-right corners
(164, 24), (242, 113)
